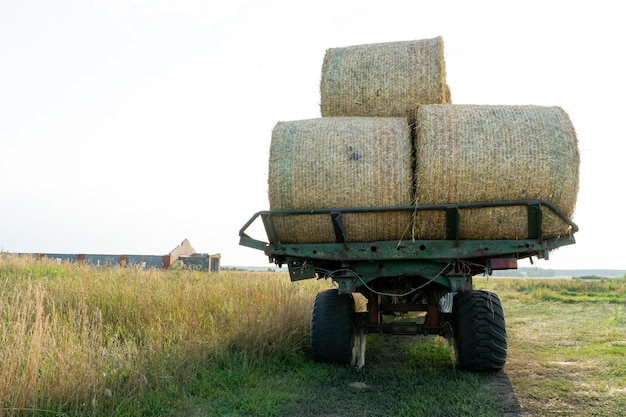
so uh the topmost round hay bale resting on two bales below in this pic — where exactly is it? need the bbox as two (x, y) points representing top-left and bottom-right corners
(320, 37), (451, 122)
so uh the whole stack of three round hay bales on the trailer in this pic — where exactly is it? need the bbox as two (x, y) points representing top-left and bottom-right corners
(268, 37), (579, 243)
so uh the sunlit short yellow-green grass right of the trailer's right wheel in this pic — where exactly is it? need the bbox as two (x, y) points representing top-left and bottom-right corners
(492, 280), (626, 416)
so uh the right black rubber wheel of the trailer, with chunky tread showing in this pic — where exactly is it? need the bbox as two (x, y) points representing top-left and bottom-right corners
(453, 291), (507, 371)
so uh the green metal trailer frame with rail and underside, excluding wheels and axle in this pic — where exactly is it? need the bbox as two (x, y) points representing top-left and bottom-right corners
(239, 200), (578, 288)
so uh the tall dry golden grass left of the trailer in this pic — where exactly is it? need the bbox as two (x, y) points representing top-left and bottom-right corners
(0, 254), (329, 417)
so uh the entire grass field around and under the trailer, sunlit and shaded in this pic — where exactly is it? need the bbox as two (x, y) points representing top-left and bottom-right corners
(0, 254), (626, 417)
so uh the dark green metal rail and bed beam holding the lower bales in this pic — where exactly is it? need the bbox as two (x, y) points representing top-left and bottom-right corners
(239, 200), (578, 264)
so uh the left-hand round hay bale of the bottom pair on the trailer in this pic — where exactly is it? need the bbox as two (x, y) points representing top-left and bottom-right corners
(268, 117), (413, 243)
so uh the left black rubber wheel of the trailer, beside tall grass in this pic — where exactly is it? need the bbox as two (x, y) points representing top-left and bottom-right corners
(311, 289), (356, 364)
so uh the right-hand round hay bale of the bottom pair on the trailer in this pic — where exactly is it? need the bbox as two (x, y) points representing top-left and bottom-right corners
(413, 105), (580, 239)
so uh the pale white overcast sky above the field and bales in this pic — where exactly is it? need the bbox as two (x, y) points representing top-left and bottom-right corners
(0, 0), (626, 269)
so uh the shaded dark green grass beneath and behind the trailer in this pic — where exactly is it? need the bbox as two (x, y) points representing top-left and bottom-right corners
(163, 336), (510, 417)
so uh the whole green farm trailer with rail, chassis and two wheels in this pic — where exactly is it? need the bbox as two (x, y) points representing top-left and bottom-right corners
(239, 200), (578, 371)
